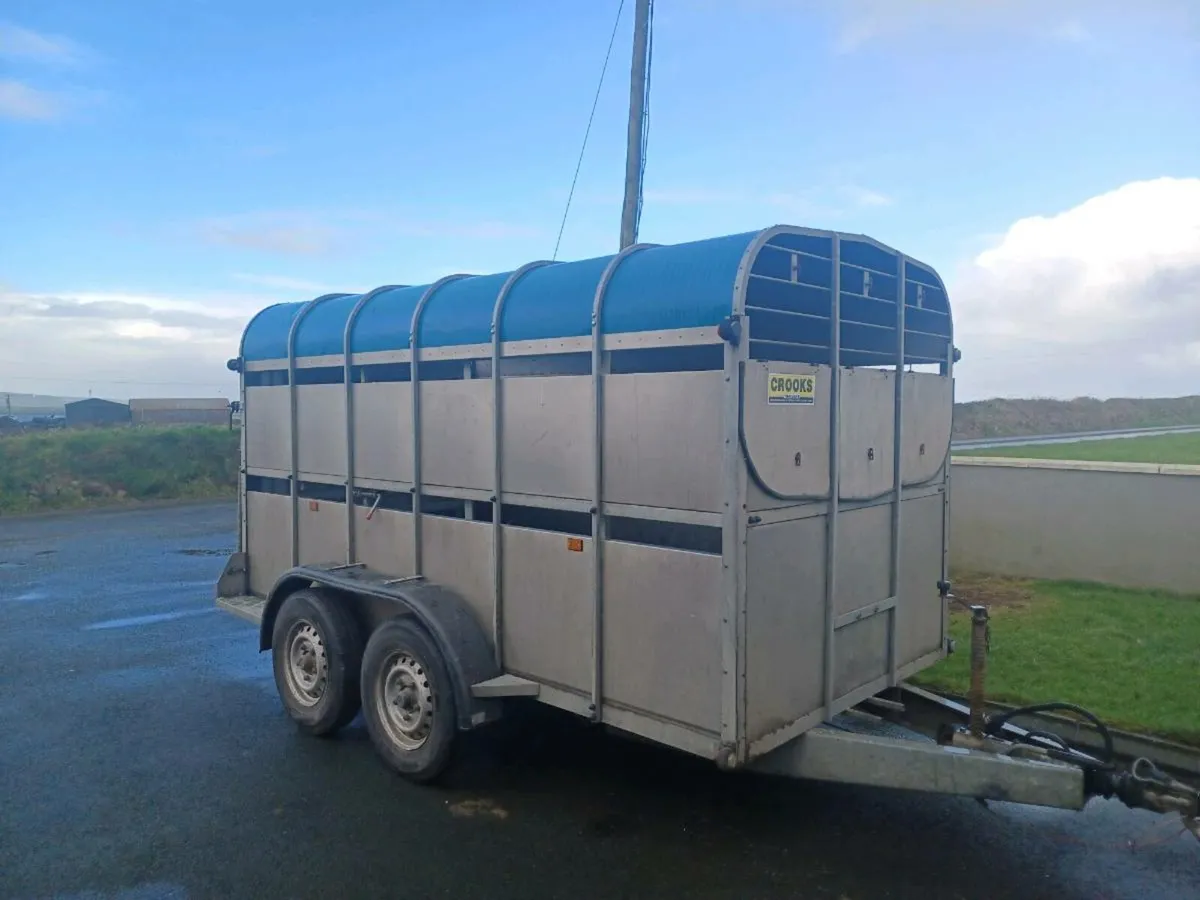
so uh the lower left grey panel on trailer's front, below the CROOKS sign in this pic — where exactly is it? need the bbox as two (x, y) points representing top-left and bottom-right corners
(745, 516), (826, 740)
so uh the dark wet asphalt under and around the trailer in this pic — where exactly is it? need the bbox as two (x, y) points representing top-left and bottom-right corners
(0, 504), (1200, 900)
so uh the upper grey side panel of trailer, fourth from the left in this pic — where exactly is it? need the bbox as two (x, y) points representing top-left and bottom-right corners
(421, 378), (494, 490)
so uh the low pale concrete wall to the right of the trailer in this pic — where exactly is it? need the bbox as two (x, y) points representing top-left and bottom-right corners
(950, 457), (1200, 594)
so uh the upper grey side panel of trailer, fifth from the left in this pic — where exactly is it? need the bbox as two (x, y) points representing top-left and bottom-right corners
(502, 376), (594, 500)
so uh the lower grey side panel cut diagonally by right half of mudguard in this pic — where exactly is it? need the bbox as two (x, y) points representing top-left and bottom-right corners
(421, 515), (494, 634)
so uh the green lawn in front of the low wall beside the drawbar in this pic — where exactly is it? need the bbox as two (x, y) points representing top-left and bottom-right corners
(914, 578), (1200, 745)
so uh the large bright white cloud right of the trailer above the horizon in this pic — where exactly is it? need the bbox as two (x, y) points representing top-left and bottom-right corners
(950, 178), (1200, 397)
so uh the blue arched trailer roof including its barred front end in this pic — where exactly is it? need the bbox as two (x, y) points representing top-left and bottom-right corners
(241, 229), (952, 365)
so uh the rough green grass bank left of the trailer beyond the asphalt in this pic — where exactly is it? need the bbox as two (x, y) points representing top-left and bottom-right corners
(0, 426), (239, 515)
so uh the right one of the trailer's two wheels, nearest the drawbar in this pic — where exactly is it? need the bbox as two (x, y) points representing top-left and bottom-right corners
(361, 618), (457, 782)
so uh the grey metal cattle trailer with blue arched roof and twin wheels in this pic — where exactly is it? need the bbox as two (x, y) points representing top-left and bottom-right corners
(217, 226), (1200, 840)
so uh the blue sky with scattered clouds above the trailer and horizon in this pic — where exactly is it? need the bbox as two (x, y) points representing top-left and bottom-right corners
(0, 0), (1200, 400)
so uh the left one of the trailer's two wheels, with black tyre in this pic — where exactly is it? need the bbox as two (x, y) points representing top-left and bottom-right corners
(271, 590), (362, 737)
